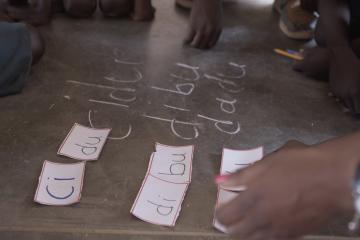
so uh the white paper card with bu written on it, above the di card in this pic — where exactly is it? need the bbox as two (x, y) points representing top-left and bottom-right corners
(149, 146), (193, 183)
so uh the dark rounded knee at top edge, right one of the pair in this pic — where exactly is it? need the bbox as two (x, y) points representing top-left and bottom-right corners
(99, 0), (131, 17)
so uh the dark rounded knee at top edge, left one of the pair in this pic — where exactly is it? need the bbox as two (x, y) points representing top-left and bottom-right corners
(64, 0), (97, 18)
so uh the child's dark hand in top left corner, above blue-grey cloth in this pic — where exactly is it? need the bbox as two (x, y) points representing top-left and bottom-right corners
(6, 0), (51, 26)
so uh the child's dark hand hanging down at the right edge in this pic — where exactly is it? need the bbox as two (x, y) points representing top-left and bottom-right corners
(330, 47), (360, 114)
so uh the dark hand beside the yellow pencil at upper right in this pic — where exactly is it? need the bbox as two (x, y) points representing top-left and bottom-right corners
(293, 47), (330, 80)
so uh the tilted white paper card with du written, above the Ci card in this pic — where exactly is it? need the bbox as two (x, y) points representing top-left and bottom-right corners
(58, 123), (111, 161)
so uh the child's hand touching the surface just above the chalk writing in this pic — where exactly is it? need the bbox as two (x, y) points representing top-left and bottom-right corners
(185, 0), (222, 49)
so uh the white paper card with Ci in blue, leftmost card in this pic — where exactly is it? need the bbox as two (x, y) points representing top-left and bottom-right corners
(34, 161), (85, 206)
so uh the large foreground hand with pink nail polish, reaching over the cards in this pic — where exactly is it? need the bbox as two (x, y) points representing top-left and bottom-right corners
(216, 140), (359, 240)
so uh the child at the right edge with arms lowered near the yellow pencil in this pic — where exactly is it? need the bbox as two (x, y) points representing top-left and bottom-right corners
(294, 0), (360, 114)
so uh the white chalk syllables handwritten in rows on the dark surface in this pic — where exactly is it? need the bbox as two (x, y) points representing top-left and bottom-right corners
(67, 55), (247, 141)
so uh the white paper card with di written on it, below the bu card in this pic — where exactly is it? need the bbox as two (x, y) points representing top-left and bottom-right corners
(131, 175), (188, 227)
